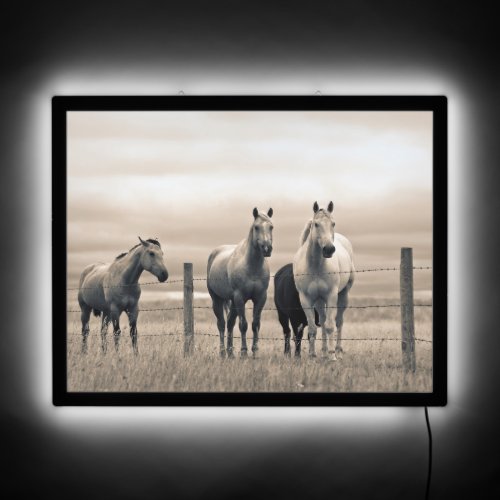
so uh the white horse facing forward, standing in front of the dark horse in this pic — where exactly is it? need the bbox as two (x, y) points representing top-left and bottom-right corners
(293, 202), (355, 360)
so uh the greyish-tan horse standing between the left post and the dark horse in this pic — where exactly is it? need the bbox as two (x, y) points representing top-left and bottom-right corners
(207, 208), (273, 357)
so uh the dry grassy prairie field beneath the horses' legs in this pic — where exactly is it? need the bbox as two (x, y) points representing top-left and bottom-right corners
(67, 296), (432, 392)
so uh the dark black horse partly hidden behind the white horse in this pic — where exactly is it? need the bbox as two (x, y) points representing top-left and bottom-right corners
(274, 263), (320, 357)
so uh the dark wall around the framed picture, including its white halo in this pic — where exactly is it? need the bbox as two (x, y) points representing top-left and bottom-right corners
(0, 1), (500, 499)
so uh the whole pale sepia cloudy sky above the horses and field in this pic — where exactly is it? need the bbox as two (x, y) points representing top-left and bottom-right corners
(67, 111), (432, 294)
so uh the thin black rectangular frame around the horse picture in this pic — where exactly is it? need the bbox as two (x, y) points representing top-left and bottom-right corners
(52, 95), (448, 406)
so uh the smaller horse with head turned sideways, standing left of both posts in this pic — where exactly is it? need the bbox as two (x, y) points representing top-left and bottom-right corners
(78, 237), (168, 354)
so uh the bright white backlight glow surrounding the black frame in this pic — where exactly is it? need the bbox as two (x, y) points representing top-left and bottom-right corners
(33, 69), (466, 434)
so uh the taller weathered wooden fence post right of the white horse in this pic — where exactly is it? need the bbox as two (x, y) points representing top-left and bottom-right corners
(399, 248), (416, 372)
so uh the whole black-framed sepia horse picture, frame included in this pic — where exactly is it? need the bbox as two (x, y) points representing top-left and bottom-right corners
(52, 95), (447, 406)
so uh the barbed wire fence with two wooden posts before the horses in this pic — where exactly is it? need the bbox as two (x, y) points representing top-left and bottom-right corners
(66, 248), (432, 372)
